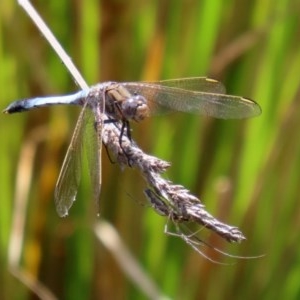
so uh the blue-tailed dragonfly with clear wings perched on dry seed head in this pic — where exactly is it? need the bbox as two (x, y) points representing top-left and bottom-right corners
(3, 77), (261, 217)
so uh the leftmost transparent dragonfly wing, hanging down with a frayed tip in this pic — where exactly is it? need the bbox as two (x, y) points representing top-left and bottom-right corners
(55, 104), (91, 217)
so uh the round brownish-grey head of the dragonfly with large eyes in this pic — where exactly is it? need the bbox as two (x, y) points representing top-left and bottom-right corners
(122, 95), (149, 122)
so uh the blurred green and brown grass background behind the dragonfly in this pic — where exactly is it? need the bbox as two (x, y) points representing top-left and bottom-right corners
(0, 0), (300, 299)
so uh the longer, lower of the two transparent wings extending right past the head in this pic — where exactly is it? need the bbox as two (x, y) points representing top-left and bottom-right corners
(123, 82), (261, 119)
